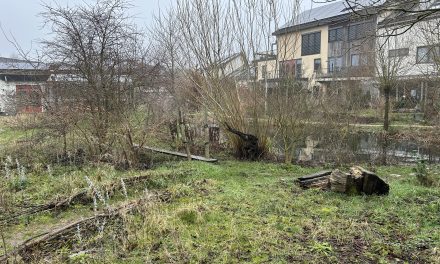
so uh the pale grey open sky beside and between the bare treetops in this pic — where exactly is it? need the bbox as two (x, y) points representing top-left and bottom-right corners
(0, 0), (324, 57)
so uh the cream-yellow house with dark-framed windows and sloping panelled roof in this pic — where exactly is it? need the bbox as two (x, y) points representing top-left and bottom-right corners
(258, 1), (377, 94)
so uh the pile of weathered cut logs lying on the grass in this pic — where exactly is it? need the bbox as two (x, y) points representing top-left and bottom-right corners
(298, 166), (390, 195)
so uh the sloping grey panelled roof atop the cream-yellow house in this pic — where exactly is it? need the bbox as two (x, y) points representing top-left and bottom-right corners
(280, 0), (383, 30)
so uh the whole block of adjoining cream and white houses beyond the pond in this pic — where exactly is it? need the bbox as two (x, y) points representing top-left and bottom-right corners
(257, 0), (440, 106)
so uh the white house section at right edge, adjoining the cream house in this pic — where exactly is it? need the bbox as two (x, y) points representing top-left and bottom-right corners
(376, 5), (440, 107)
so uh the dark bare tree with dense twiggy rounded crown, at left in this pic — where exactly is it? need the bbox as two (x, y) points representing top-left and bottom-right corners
(41, 0), (150, 160)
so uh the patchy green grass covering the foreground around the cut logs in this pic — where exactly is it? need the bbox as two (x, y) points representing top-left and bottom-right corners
(0, 161), (440, 263)
